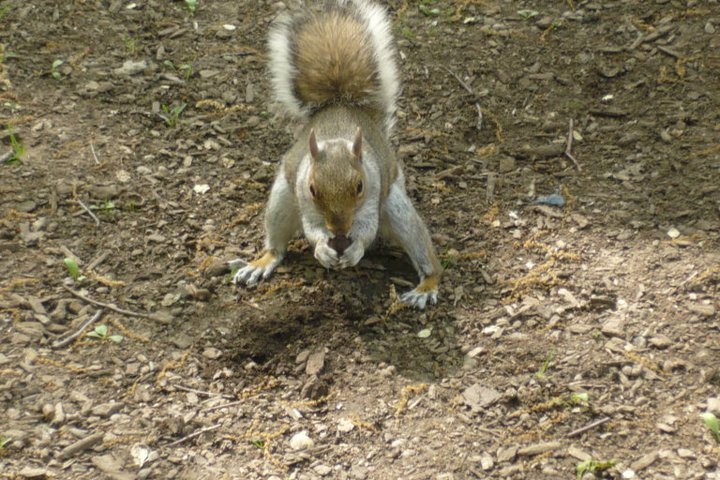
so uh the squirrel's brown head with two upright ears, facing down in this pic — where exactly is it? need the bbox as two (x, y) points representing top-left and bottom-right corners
(307, 128), (365, 236)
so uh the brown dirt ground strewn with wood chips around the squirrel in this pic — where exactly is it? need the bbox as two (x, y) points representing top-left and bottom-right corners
(0, 0), (720, 480)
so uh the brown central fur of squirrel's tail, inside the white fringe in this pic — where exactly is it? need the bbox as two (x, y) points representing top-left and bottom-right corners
(295, 11), (378, 105)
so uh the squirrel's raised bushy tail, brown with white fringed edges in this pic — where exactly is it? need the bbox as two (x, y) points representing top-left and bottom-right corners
(269, 0), (400, 134)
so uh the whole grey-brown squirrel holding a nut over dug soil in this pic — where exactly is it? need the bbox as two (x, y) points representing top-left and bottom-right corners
(230, 0), (442, 309)
